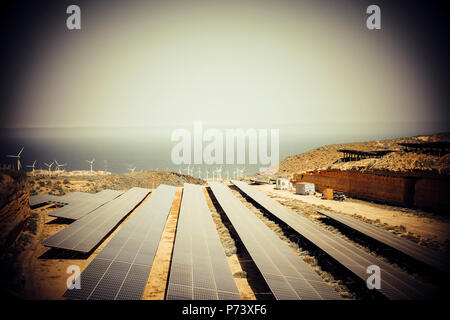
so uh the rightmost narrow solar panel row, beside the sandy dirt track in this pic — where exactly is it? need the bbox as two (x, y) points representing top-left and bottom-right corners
(318, 210), (450, 272)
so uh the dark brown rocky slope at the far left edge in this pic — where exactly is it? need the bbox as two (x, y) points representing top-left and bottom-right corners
(0, 171), (30, 253)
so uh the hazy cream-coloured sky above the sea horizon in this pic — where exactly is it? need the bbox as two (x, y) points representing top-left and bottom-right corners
(1, 1), (448, 128)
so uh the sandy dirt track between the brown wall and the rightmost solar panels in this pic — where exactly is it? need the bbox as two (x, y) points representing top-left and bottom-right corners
(255, 184), (450, 246)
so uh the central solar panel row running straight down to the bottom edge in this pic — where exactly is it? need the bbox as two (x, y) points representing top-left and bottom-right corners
(166, 183), (240, 300)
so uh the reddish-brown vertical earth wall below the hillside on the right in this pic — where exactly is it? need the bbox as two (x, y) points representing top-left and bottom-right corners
(294, 170), (450, 211)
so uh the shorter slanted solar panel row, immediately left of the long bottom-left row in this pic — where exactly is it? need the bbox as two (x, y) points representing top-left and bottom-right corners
(42, 187), (150, 253)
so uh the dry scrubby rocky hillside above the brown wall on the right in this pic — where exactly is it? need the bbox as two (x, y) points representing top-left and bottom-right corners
(279, 133), (450, 175)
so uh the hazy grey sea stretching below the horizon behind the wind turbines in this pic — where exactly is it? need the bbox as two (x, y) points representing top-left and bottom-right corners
(0, 123), (446, 178)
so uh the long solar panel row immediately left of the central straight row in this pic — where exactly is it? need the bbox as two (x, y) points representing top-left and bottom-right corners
(63, 185), (177, 300)
